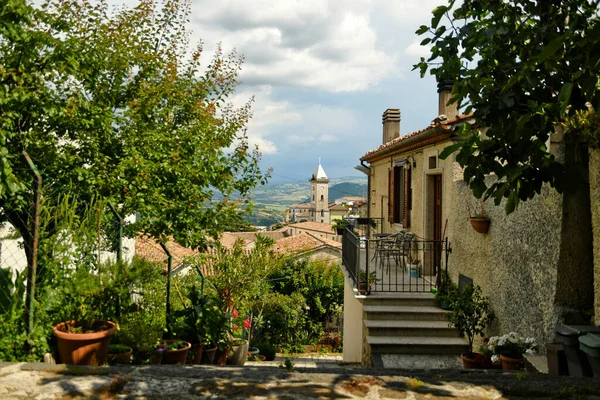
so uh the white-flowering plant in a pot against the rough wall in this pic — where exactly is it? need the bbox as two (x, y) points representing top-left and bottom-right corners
(488, 332), (537, 370)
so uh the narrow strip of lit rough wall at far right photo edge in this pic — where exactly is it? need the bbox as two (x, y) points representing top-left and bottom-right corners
(589, 149), (600, 325)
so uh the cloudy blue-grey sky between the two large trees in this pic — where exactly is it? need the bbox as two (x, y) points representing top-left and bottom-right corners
(171, 0), (444, 182)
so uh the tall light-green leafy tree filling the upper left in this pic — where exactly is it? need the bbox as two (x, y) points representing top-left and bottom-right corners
(0, 0), (267, 257)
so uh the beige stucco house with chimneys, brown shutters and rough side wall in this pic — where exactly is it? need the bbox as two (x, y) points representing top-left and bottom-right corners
(352, 80), (600, 351)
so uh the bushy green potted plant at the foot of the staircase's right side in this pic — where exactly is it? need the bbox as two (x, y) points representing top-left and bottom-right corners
(446, 283), (493, 369)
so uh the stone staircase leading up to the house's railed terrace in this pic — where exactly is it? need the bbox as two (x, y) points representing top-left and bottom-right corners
(363, 293), (467, 369)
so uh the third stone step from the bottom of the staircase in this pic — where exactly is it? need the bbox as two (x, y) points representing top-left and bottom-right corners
(365, 320), (460, 337)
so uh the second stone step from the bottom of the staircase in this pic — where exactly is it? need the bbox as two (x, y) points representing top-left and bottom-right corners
(367, 336), (467, 355)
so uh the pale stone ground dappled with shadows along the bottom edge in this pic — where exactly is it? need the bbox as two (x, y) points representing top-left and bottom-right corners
(0, 355), (600, 400)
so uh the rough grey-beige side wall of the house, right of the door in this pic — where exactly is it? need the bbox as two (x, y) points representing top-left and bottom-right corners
(445, 181), (562, 343)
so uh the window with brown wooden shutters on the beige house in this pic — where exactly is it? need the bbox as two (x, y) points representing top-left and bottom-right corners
(388, 164), (412, 228)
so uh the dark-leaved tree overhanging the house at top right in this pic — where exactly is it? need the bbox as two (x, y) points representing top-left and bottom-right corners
(415, 0), (600, 213)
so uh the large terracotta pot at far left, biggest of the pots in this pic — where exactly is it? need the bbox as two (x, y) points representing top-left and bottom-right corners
(52, 320), (117, 365)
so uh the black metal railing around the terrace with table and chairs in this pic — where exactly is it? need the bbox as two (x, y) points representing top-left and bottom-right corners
(342, 229), (452, 294)
